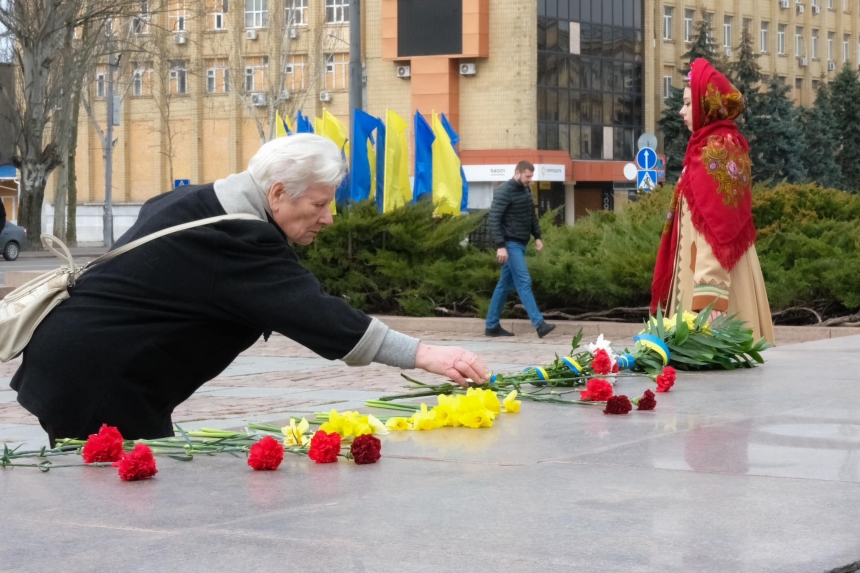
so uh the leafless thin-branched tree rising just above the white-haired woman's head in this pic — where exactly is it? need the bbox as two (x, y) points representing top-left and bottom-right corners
(212, 0), (344, 143)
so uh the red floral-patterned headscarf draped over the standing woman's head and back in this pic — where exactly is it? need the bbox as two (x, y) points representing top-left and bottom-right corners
(651, 59), (755, 313)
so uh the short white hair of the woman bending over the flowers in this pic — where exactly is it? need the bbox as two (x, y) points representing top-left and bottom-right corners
(248, 133), (346, 199)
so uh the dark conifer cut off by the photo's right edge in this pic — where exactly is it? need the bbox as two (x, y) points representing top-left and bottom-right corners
(831, 63), (860, 193)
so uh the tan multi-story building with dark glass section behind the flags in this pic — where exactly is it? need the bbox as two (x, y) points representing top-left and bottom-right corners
(40, 0), (848, 240)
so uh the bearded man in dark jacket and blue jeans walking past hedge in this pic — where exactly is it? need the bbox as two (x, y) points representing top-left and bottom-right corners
(484, 161), (555, 338)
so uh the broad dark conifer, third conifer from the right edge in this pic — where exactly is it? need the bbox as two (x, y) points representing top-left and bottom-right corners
(747, 77), (806, 183)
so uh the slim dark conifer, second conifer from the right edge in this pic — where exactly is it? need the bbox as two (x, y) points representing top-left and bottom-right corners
(801, 81), (842, 189)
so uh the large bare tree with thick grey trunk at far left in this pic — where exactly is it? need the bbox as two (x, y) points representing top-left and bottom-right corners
(0, 0), (151, 249)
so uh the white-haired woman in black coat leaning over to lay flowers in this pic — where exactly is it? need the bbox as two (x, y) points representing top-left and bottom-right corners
(12, 135), (488, 441)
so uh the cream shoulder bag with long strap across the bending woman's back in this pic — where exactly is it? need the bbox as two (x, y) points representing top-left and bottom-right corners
(0, 213), (260, 362)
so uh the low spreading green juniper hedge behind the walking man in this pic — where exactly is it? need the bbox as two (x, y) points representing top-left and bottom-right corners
(294, 185), (860, 316)
